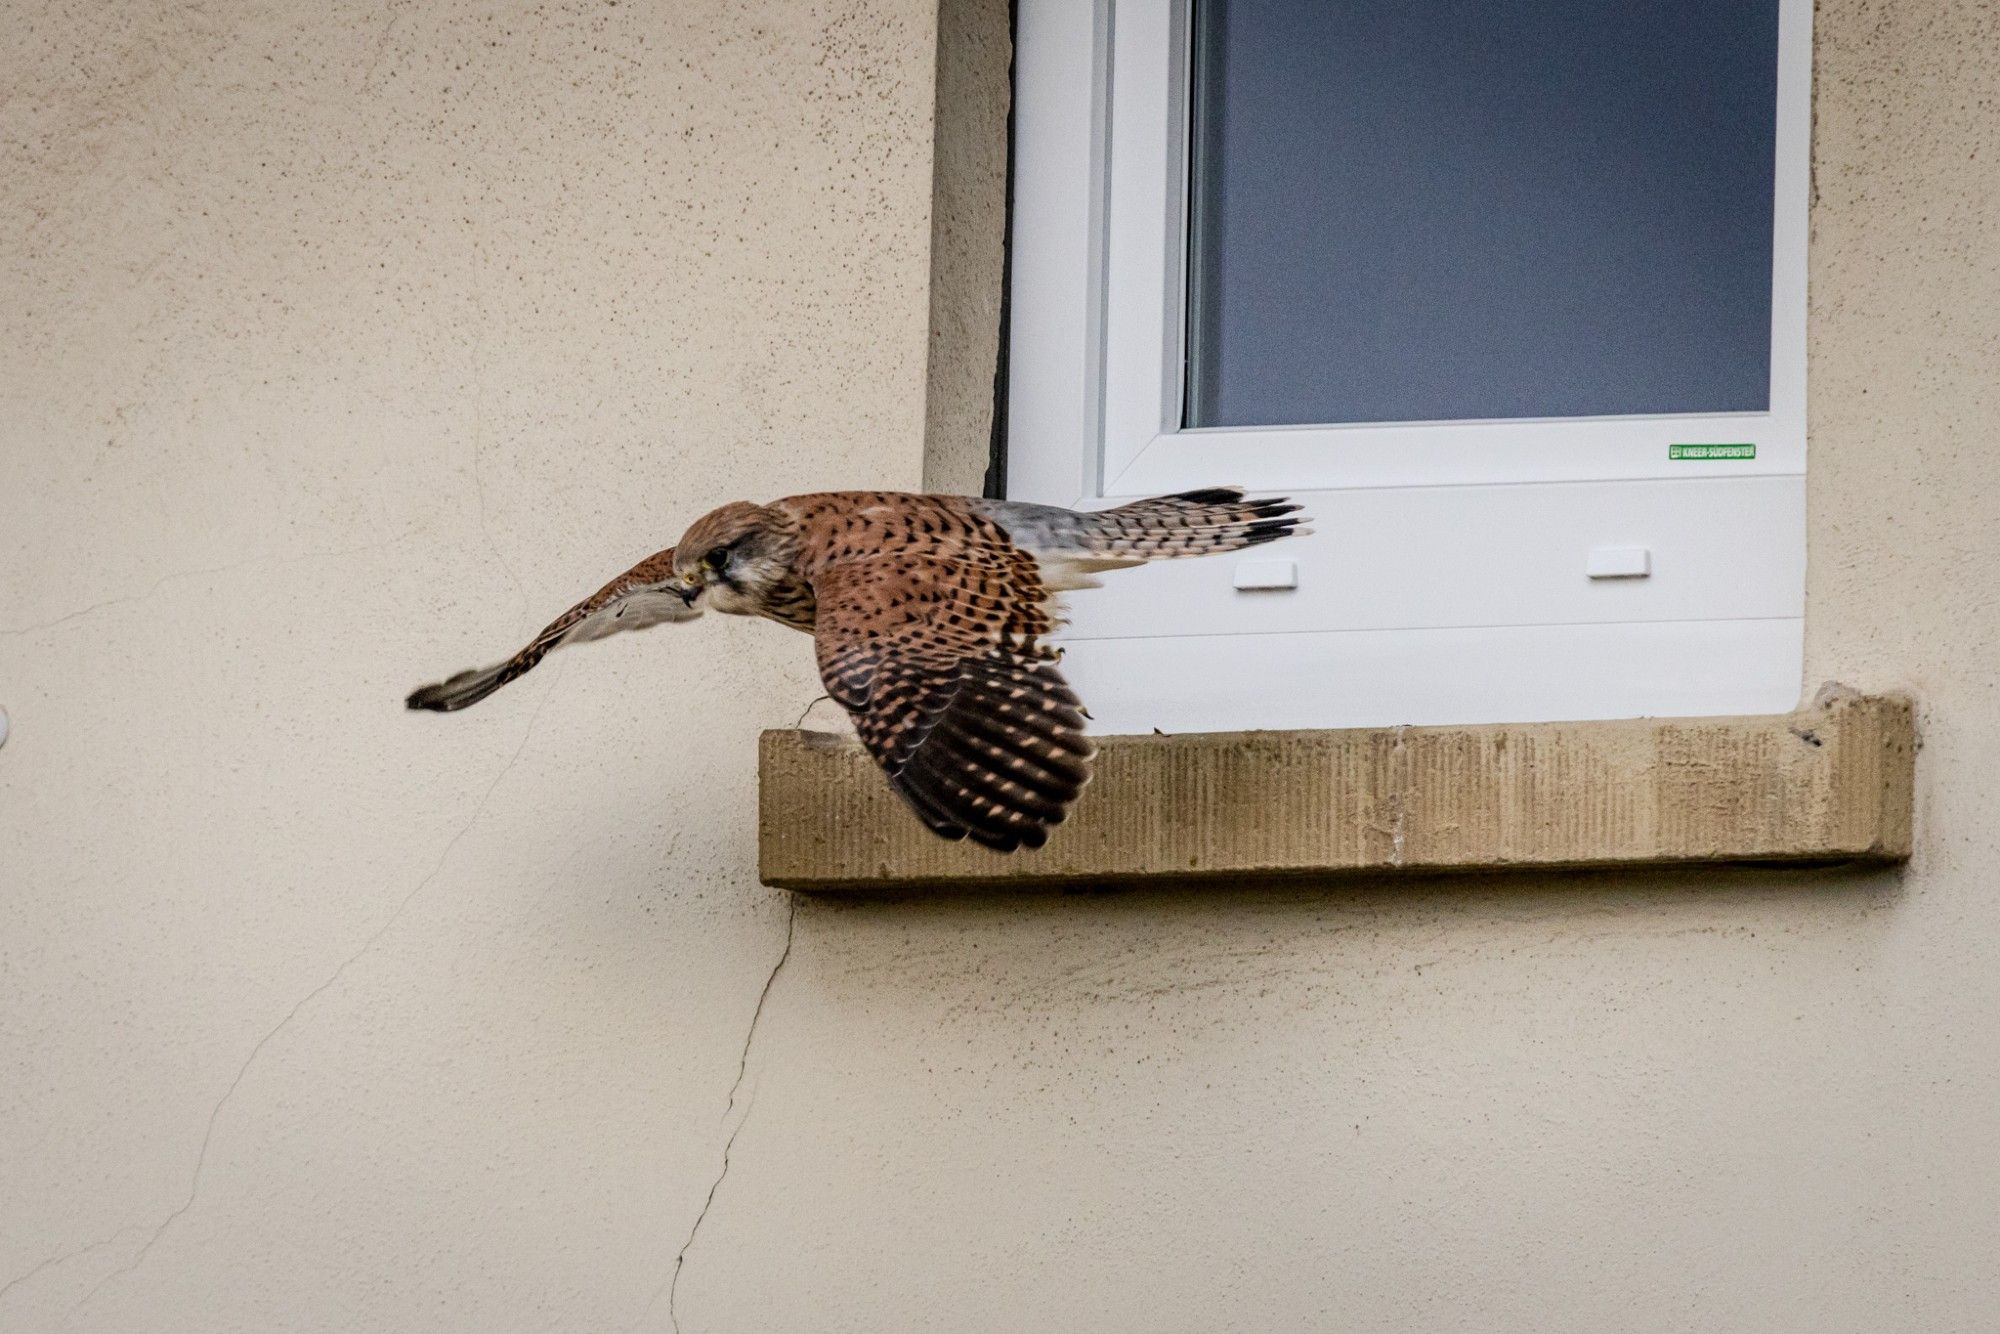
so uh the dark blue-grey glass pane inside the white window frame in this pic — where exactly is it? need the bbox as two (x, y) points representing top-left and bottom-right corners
(1188, 0), (1778, 426)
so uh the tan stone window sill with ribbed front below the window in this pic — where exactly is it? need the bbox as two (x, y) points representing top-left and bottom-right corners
(758, 686), (1916, 892)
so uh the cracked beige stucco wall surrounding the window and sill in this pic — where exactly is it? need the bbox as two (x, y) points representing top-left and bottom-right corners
(0, 0), (2000, 1334)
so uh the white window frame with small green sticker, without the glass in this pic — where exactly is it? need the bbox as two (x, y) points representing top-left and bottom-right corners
(1006, 0), (1812, 730)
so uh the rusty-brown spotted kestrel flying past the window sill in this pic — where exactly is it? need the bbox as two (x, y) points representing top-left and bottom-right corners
(408, 488), (1308, 852)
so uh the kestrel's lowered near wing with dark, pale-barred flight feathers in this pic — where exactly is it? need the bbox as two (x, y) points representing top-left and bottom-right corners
(814, 548), (1096, 852)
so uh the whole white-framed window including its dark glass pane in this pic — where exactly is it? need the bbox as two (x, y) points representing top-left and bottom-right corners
(1006, 0), (1810, 732)
